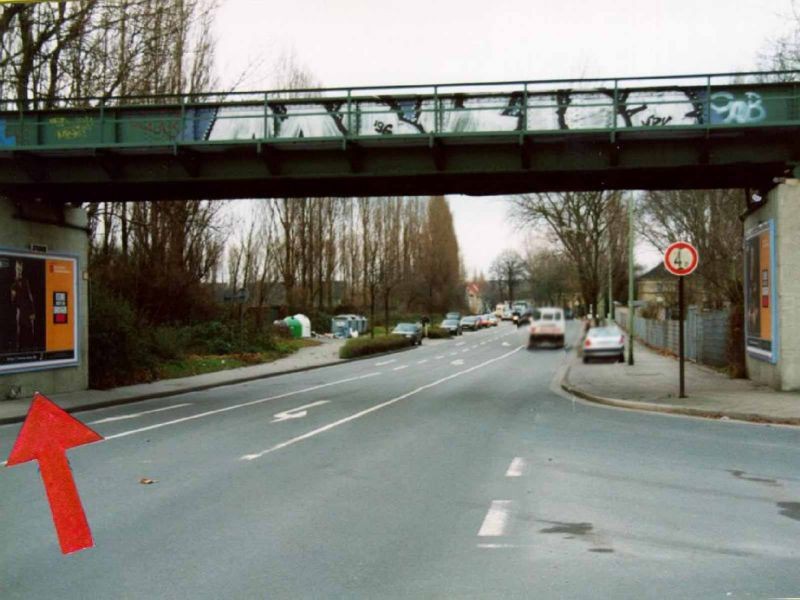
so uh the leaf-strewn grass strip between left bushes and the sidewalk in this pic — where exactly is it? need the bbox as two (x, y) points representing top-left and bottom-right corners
(159, 339), (321, 379)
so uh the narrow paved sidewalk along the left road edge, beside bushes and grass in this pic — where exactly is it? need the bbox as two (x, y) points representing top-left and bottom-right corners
(0, 338), (348, 425)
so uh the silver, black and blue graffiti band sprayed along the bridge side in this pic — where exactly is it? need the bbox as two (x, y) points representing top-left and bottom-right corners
(0, 87), (776, 146)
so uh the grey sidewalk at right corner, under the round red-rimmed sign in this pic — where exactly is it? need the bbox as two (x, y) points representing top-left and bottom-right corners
(561, 343), (800, 425)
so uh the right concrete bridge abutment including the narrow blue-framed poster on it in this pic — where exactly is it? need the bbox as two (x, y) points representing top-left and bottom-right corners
(744, 179), (800, 390)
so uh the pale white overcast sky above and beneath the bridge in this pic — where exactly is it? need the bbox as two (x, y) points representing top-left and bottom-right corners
(216, 0), (791, 273)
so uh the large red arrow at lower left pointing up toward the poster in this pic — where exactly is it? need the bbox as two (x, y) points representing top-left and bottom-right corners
(7, 392), (103, 554)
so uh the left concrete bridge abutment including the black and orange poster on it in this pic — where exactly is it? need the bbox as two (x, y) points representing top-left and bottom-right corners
(0, 197), (89, 401)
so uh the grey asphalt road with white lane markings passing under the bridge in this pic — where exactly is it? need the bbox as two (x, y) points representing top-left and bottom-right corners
(0, 324), (800, 600)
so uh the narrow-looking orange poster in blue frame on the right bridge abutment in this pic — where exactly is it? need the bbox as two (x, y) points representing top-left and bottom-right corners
(744, 220), (777, 362)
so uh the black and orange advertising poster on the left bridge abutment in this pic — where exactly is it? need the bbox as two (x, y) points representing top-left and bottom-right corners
(0, 250), (78, 373)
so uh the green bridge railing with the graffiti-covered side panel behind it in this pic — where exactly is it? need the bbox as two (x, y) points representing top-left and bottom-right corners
(0, 71), (800, 150)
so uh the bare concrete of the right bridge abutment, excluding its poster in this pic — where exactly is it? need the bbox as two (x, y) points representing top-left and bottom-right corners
(744, 179), (800, 390)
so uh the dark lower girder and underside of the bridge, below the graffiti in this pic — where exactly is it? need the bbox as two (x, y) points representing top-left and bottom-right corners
(0, 127), (800, 203)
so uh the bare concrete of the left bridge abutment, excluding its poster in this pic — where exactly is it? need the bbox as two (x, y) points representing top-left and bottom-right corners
(0, 198), (89, 401)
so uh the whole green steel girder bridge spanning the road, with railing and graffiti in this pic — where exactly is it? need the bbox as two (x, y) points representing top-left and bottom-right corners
(0, 72), (800, 203)
